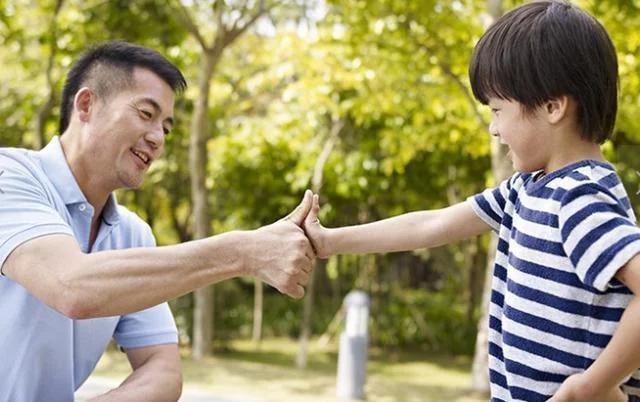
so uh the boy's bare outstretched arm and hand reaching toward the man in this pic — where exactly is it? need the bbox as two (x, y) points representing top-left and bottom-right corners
(304, 194), (491, 258)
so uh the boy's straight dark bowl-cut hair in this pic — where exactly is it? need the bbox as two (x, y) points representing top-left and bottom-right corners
(469, 0), (618, 144)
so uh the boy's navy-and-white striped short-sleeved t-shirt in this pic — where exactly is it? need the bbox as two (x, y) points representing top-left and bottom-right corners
(469, 160), (640, 402)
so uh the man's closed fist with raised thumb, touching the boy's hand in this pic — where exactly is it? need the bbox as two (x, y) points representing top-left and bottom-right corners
(244, 190), (315, 299)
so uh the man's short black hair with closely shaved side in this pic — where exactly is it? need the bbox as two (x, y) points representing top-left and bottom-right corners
(59, 41), (187, 135)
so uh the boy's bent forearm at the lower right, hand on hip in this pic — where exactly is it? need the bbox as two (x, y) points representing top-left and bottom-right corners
(584, 296), (640, 394)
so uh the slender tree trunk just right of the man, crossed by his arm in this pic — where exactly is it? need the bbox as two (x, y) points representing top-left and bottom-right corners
(189, 51), (218, 360)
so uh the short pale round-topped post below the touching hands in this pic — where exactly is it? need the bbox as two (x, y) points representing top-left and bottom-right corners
(336, 290), (369, 400)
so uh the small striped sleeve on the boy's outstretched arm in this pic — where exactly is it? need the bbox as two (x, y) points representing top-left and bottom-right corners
(467, 173), (519, 232)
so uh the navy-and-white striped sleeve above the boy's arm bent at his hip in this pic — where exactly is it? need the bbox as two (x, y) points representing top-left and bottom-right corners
(558, 182), (640, 291)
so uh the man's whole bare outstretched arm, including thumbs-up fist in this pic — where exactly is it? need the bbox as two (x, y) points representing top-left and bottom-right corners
(3, 192), (315, 319)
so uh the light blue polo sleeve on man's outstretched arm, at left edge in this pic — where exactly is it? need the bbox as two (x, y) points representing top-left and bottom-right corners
(0, 153), (73, 272)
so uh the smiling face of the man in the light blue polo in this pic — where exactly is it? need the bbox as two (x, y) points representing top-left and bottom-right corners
(88, 68), (174, 190)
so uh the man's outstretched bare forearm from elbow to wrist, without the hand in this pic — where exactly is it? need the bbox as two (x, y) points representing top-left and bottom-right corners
(61, 232), (246, 319)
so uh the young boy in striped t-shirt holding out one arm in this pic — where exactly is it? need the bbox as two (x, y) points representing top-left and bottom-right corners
(305, 1), (640, 402)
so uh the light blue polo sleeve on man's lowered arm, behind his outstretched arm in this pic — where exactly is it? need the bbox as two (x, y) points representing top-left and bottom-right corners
(113, 223), (178, 349)
